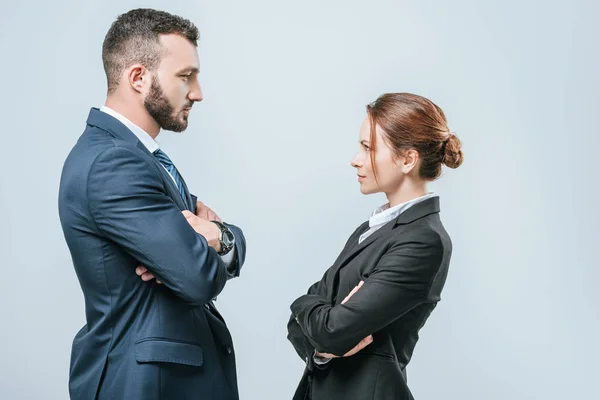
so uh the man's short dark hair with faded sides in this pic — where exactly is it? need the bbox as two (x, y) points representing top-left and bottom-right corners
(102, 8), (198, 93)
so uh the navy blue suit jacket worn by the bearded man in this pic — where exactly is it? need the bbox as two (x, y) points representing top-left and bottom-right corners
(59, 108), (246, 400)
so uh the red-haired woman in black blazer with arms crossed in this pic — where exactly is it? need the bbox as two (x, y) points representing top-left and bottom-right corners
(288, 93), (463, 400)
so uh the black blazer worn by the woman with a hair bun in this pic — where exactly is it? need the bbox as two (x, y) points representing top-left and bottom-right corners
(288, 197), (452, 400)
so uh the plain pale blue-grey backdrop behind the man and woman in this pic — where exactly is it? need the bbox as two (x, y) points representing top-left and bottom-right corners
(0, 0), (600, 400)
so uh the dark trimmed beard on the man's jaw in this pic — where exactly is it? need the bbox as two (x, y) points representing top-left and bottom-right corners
(144, 76), (192, 132)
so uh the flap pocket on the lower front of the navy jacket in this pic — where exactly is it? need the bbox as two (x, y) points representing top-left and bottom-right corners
(134, 338), (204, 367)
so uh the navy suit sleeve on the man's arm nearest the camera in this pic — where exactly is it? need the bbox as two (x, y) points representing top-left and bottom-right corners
(87, 147), (227, 306)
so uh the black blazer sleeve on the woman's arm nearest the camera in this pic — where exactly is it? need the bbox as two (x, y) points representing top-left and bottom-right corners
(290, 230), (443, 356)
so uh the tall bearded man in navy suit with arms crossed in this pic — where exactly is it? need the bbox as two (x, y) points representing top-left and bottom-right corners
(59, 9), (246, 400)
